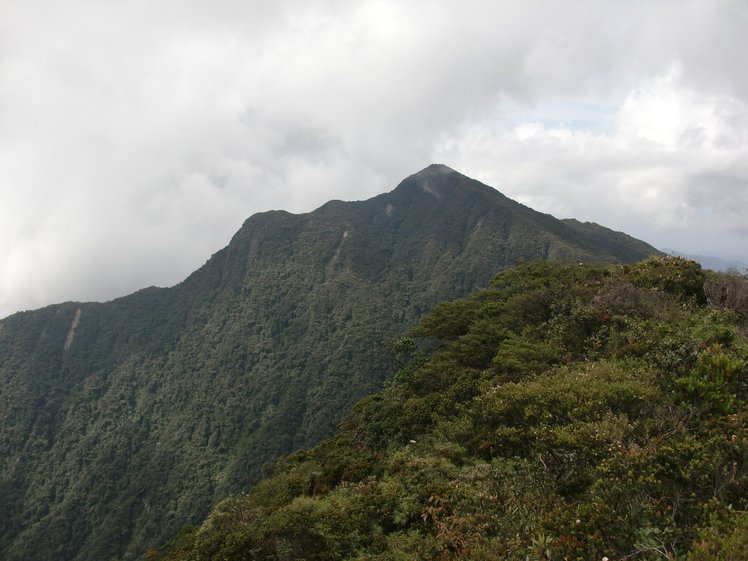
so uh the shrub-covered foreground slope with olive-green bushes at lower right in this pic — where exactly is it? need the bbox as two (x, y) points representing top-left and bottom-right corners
(152, 258), (748, 561)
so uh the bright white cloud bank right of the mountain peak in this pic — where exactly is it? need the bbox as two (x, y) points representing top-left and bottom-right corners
(437, 61), (748, 252)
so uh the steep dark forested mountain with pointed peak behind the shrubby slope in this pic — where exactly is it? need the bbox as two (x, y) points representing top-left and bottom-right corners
(0, 166), (657, 560)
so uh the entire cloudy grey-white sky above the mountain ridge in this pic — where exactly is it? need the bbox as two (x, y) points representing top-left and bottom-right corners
(0, 0), (748, 317)
